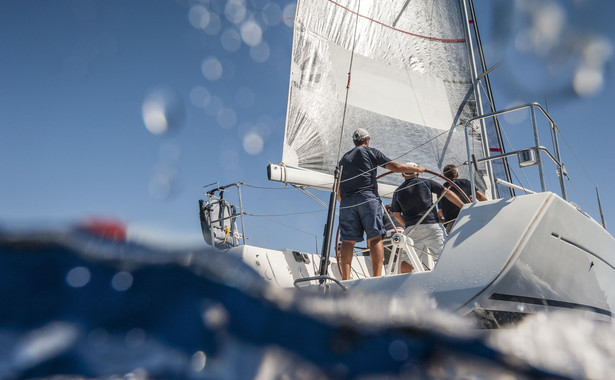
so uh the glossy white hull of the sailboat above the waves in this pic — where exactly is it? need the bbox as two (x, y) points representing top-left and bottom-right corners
(224, 193), (615, 327)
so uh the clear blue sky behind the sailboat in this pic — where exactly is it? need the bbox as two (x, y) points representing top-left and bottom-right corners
(0, 0), (615, 251)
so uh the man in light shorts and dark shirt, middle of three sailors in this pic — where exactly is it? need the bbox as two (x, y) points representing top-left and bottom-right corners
(391, 163), (463, 272)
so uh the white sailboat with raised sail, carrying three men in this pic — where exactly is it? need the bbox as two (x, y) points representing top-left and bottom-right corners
(199, 0), (615, 328)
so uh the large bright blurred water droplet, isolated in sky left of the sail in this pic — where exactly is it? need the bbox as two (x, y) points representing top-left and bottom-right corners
(141, 88), (184, 135)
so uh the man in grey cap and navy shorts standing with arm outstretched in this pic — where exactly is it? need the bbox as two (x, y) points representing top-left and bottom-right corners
(338, 128), (425, 280)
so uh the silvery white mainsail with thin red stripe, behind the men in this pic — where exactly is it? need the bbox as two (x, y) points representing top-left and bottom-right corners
(283, 0), (483, 193)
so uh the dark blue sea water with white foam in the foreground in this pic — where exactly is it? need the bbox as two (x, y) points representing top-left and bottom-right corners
(0, 228), (615, 379)
